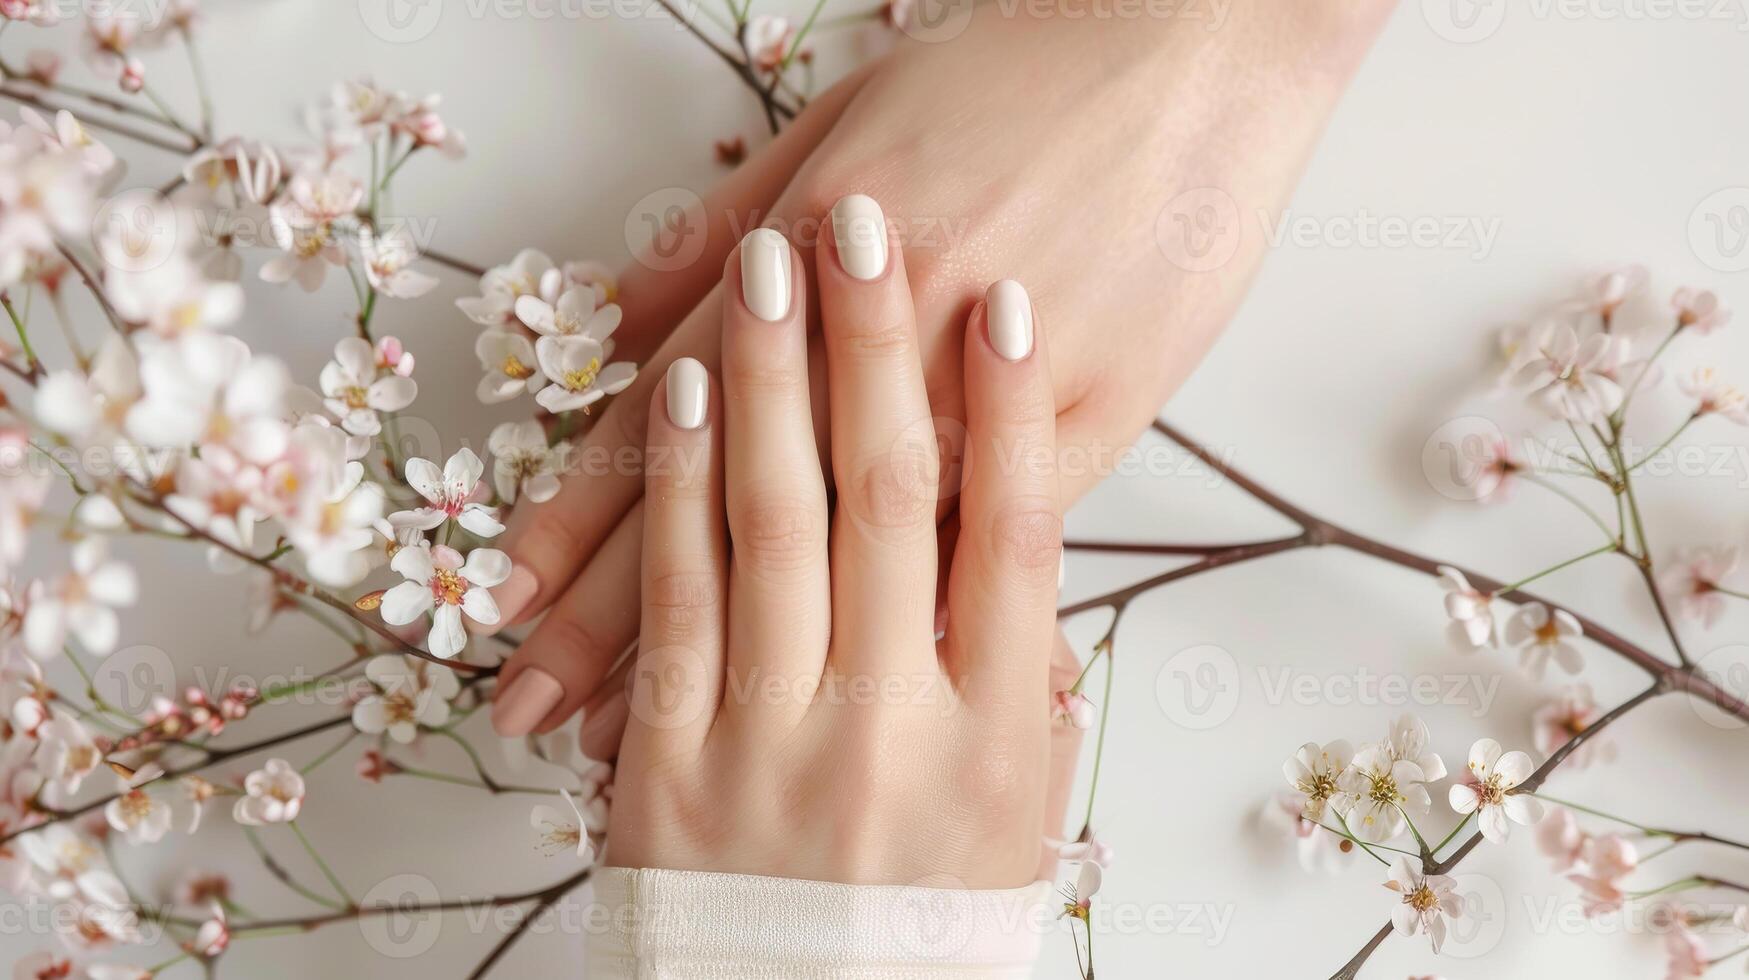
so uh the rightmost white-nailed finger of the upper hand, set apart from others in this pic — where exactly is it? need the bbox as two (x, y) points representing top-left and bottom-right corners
(944, 280), (1063, 711)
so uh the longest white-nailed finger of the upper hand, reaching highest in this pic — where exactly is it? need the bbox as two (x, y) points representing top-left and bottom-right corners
(815, 194), (939, 670)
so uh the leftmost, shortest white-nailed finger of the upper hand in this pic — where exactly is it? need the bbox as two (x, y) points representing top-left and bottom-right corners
(624, 357), (729, 760)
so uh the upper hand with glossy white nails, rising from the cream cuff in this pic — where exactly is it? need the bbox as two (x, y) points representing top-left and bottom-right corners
(607, 198), (1062, 889)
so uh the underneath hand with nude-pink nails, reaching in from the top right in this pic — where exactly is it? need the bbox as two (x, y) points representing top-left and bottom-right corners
(493, 0), (1389, 742)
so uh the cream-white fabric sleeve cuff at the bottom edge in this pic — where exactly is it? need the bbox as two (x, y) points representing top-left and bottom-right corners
(588, 868), (1051, 980)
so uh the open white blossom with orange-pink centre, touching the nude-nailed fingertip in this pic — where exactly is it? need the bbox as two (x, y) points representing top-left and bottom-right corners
(383, 544), (511, 660)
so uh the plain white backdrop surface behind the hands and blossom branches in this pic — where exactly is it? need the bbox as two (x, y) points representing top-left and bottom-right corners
(0, 0), (1749, 978)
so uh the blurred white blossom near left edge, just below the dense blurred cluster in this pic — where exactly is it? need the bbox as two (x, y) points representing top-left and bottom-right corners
(24, 536), (138, 658)
